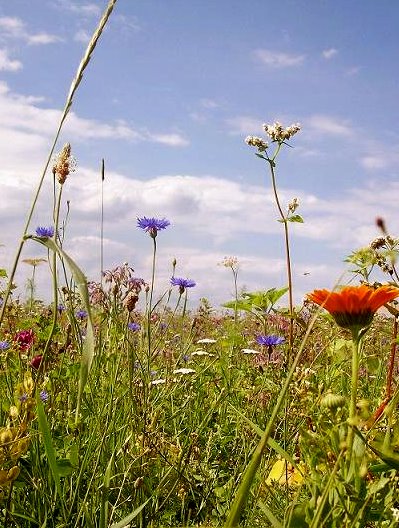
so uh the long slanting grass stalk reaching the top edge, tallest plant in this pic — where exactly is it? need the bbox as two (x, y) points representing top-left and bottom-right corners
(0, 0), (117, 326)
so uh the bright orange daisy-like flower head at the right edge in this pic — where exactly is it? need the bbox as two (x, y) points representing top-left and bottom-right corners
(307, 284), (399, 333)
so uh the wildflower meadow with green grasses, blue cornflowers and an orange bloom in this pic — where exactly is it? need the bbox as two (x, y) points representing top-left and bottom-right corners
(0, 0), (399, 528)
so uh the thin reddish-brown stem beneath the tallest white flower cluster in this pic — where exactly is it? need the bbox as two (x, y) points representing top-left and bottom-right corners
(266, 142), (294, 361)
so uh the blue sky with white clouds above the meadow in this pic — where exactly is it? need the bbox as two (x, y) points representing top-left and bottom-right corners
(0, 0), (399, 306)
